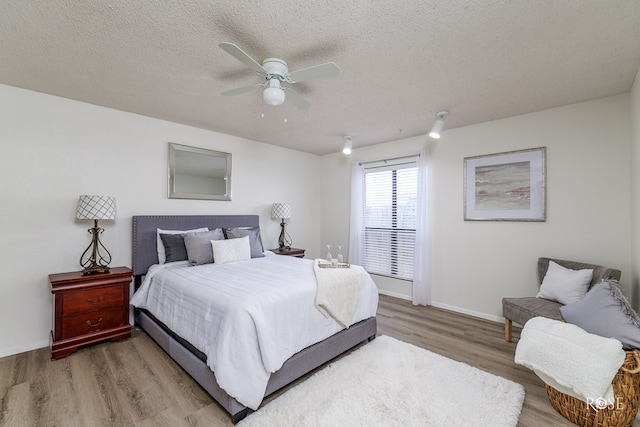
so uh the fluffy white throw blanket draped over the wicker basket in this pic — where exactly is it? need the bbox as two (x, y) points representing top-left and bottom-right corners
(515, 317), (625, 405)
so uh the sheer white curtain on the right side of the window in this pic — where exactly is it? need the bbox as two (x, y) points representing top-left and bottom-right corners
(412, 151), (431, 305)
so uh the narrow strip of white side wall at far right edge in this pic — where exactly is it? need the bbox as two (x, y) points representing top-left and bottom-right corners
(630, 69), (640, 308)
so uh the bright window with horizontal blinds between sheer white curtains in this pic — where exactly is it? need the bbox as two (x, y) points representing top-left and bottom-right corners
(361, 162), (418, 280)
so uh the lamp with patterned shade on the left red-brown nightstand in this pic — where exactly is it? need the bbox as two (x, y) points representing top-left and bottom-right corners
(76, 195), (116, 274)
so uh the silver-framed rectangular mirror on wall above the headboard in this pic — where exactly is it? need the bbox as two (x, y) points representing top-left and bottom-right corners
(169, 143), (231, 200)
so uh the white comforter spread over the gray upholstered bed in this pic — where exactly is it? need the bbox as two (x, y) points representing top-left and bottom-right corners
(131, 253), (378, 409)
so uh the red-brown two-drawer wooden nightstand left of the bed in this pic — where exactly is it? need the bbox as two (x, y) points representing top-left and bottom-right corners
(49, 267), (133, 359)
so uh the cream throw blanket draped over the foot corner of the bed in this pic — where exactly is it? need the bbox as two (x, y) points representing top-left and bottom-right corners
(313, 260), (366, 328)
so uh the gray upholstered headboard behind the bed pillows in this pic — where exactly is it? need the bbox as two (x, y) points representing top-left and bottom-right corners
(132, 215), (260, 276)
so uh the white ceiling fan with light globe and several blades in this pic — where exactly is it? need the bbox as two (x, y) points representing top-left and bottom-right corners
(218, 43), (340, 108)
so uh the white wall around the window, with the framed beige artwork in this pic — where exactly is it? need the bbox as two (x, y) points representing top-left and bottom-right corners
(320, 94), (632, 320)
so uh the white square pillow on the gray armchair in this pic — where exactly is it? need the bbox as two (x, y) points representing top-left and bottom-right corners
(536, 261), (593, 304)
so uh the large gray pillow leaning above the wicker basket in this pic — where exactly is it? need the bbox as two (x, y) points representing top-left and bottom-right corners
(560, 280), (640, 349)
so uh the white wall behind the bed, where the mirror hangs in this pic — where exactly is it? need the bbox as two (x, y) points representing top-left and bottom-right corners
(0, 85), (320, 356)
